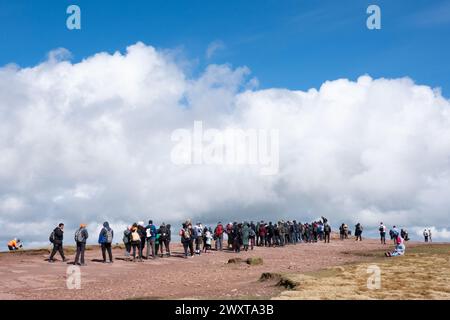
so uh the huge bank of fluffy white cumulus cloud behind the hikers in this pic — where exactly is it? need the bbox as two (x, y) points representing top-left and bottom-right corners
(0, 43), (450, 248)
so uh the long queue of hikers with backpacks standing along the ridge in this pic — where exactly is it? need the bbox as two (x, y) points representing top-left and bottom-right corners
(8, 217), (431, 266)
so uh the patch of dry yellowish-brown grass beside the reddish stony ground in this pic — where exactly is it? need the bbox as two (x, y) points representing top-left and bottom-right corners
(270, 245), (450, 300)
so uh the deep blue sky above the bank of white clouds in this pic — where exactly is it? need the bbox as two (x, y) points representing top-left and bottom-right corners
(0, 0), (450, 97)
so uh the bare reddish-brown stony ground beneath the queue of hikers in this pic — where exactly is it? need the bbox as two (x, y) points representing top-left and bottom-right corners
(0, 239), (436, 299)
